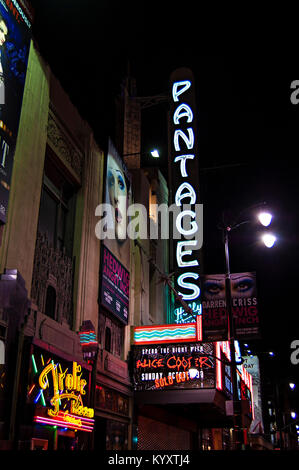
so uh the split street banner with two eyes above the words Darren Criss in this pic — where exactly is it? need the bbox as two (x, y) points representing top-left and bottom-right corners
(201, 272), (260, 341)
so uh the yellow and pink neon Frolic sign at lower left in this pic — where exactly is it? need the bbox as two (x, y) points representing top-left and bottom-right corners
(27, 348), (94, 432)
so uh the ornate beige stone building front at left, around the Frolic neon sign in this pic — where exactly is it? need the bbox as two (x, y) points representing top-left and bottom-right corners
(0, 15), (104, 449)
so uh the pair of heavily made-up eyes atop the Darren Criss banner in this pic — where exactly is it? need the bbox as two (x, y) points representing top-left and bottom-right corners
(203, 273), (255, 300)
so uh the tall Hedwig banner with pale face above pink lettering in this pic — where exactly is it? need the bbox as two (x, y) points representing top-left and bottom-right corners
(100, 139), (131, 324)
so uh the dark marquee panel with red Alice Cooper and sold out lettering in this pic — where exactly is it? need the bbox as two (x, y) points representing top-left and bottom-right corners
(132, 343), (215, 391)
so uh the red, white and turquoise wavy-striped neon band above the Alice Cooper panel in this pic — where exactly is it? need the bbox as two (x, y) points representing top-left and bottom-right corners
(134, 315), (202, 344)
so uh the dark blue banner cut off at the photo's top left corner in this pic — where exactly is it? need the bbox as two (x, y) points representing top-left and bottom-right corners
(0, 0), (31, 223)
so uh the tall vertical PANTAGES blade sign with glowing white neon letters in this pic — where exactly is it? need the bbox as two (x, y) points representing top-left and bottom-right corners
(170, 69), (202, 301)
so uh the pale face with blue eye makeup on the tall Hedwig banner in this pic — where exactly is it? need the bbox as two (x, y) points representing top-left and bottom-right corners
(107, 155), (128, 242)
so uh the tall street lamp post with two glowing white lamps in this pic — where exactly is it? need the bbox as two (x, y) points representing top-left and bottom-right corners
(218, 203), (276, 450)
